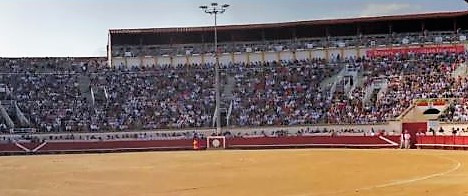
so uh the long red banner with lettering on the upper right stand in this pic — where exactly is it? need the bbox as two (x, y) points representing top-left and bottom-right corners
(366, 45), (465, 57)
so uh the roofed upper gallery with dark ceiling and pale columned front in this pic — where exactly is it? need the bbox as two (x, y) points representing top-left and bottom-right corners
(108, 11), (468, 67)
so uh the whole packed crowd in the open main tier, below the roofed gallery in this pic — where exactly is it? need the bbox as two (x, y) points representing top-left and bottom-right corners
(0, 49), (468, 132)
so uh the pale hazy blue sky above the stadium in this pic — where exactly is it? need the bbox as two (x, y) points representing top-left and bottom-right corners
(0, 0), (468, 57)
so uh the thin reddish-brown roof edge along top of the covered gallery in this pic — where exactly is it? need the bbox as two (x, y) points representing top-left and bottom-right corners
(109, 11), (468, 34)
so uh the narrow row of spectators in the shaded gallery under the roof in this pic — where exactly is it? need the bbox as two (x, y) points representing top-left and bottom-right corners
(112, 31), (467, 57)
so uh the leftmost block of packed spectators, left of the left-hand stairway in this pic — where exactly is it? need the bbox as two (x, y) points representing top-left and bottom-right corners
(0, 58), (105, 132)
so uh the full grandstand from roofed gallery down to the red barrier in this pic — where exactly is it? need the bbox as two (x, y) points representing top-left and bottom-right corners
(0, 12), (468, 153)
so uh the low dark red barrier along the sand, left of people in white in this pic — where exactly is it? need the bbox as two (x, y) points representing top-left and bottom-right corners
(0, 136), (395, 153)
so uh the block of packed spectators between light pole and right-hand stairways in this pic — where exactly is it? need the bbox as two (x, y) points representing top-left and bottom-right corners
(232, 59), (339, 126)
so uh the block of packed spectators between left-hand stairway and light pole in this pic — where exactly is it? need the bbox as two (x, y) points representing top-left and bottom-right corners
(91, 69), (215, 129)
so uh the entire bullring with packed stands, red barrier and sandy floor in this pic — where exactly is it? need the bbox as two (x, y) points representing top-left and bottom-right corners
(0, 3), (468, 196)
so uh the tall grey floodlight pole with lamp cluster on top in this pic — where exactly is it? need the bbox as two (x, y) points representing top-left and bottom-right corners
(199, 3), (229, 134)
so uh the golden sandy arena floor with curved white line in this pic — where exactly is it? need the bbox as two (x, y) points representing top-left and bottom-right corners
(0, 149), (468, 196)
